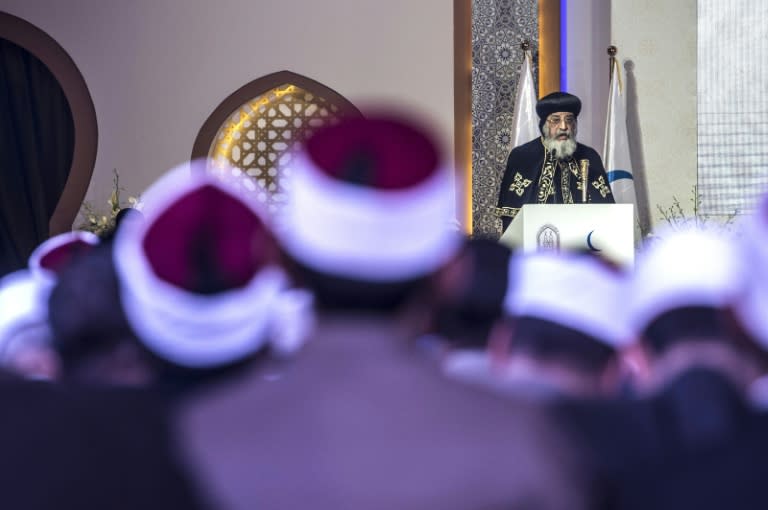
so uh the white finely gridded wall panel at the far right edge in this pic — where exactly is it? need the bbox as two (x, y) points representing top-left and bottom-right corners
(696, 0), (768, 217)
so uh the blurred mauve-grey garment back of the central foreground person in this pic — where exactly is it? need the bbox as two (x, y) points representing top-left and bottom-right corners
(179, 317), (588, 510)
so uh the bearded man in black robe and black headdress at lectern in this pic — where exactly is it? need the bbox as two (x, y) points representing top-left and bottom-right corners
(496, 92), (614, 230)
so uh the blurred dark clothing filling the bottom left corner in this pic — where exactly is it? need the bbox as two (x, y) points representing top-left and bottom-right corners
(0, 381), (203, 509)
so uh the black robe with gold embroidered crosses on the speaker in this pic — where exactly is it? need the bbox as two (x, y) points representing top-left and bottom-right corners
(496, 138), (615, 230)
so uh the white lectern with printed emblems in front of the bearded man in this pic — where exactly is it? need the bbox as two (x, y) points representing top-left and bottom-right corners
(499, 204), (635, 267)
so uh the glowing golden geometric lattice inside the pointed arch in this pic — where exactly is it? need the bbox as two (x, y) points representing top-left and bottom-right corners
(208, 84), (339, 215)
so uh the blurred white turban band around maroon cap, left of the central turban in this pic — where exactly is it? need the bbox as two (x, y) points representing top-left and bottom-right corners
(114, 162), (286, 368)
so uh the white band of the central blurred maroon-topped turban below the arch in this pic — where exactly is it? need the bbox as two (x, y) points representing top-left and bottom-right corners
(280, 151), (460, 282)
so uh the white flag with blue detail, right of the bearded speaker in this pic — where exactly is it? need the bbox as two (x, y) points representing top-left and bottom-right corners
(603, 58), (636, 204)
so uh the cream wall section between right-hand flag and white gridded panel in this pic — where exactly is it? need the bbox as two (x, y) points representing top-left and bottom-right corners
(611, 0), (697, 227)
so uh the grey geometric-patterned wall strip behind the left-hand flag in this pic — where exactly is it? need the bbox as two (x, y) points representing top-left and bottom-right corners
(472, 0), (539, 238)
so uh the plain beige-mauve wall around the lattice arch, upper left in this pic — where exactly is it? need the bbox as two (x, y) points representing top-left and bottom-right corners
(0, 0), (453, 217)
